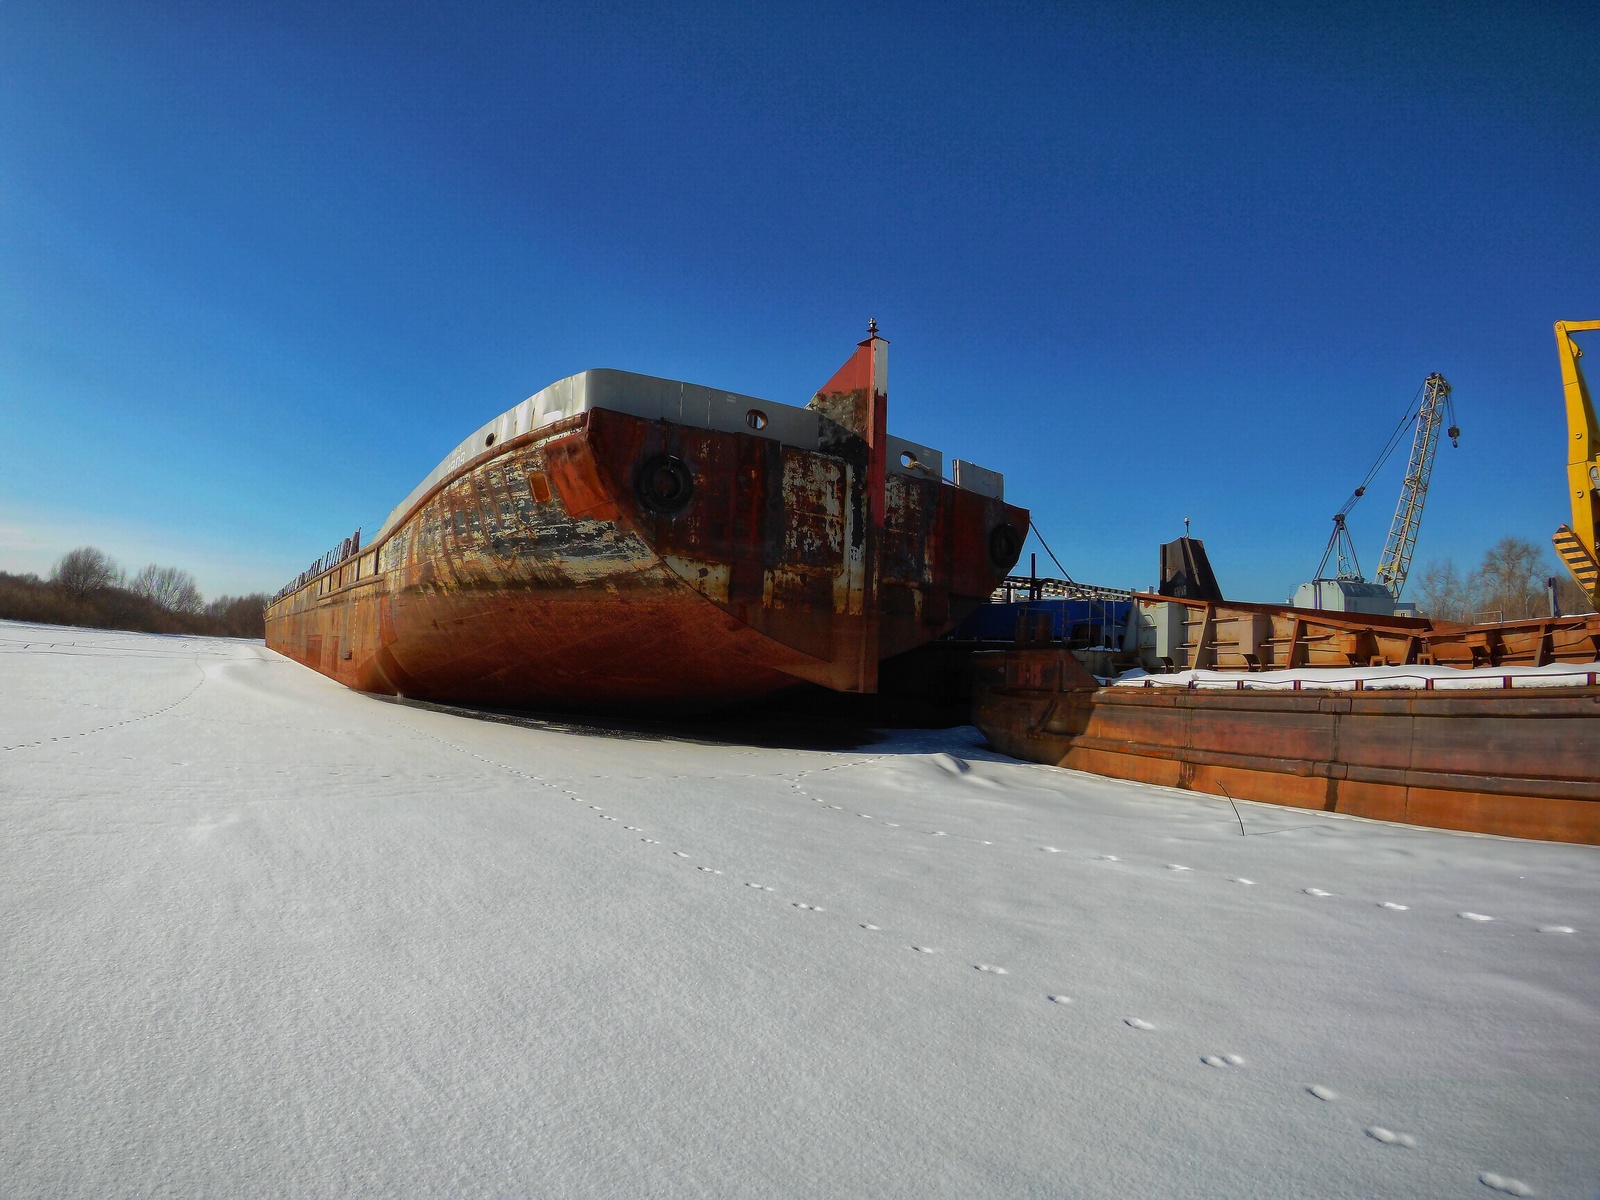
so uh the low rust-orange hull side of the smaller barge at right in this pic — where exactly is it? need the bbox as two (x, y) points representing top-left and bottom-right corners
(974, 650), (1600, 845)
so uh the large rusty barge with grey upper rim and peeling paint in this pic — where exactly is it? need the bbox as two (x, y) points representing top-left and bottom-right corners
(267, 326), (1029, 712)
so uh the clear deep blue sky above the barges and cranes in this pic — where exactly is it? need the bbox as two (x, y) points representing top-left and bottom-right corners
(0, 0), (1600, 600)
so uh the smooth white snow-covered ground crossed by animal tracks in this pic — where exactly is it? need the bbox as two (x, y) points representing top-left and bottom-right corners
(9, 622), (1600, 1197)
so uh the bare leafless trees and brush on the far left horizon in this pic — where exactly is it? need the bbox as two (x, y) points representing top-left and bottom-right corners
(0, 546), (267, 637)
